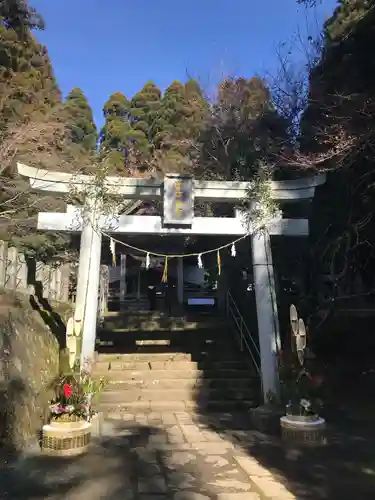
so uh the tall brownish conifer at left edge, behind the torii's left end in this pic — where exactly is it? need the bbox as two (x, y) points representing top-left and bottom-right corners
(0, 0), (80, 253)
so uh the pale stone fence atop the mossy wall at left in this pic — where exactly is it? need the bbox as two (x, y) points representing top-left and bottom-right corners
(0, 241), (70, 302)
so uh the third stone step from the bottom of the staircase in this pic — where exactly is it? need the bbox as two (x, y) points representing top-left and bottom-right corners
(101, 377), (259, 392)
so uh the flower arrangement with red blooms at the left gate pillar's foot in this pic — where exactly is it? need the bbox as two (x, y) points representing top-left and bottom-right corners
(49, 371), (106, 421)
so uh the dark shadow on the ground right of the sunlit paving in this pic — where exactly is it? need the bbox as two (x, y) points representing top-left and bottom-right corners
(195, 411), (375, 500)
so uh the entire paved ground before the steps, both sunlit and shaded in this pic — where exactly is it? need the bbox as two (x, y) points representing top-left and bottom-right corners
(0, 412), (375, 500)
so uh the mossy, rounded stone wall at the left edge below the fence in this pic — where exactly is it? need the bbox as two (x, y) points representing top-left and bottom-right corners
(0, 293), (69, 451)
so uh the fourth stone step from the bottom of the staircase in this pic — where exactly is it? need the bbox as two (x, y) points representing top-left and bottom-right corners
(93, 364), (258, 378)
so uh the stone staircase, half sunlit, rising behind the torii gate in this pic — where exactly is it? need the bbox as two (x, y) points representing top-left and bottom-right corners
(94, 312), (260, 418)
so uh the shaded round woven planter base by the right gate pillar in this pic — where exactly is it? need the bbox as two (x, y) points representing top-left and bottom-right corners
(280, 415), (326, 446)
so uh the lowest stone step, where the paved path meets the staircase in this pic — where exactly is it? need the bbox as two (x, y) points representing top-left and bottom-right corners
(97, 398), (259, 418)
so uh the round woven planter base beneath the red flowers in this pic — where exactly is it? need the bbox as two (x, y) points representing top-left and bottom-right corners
(42, 420), (91, 457)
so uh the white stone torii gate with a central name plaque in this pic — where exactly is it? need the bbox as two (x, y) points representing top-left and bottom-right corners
(18, 164), (325, 399)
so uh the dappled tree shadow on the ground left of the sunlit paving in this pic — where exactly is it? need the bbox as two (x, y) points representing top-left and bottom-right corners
(0, 422), (218, 500)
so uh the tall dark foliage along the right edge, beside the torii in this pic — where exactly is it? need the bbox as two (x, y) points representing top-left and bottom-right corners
(301, 0), (375, 307)
